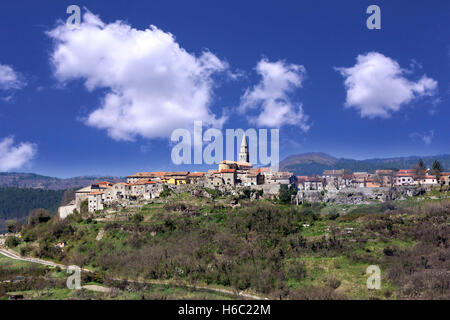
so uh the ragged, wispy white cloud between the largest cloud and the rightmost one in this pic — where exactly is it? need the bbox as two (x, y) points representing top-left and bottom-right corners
(239, 59), (310, 131)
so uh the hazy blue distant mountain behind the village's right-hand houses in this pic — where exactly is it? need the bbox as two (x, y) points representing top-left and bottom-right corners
(280, 152), (450, 175)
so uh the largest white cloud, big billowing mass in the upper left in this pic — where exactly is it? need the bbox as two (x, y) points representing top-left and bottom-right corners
(48, 12), (228, 140)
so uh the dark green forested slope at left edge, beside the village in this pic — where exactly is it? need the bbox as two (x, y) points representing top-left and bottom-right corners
(0, 187), (65, 232)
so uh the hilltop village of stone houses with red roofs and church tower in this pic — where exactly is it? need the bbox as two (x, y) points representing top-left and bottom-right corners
(59, 136), (450, 217)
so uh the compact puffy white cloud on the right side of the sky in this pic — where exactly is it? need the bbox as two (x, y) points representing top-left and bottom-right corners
(336, 52), (438, 118)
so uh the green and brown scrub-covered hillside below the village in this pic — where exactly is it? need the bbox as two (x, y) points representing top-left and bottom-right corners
(4, 192), (450, 300)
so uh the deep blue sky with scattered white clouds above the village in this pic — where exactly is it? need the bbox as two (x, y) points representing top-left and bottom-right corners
(0, 0), (450, 177)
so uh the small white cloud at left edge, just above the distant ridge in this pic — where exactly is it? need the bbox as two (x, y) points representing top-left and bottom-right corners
(0, 137), (37, 171)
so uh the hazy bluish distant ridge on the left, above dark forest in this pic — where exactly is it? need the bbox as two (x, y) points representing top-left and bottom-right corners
(0, 172), (123, 190)
